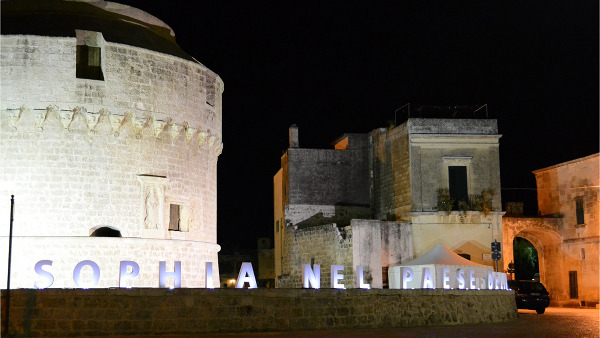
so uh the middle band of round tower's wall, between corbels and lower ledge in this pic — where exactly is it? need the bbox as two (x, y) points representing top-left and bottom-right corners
(0, 107), (219, 243)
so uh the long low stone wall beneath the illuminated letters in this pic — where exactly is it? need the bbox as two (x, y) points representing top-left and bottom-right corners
(2, 289), (517, 337)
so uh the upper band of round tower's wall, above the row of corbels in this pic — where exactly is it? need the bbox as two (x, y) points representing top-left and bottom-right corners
(0, 35), (223, 132)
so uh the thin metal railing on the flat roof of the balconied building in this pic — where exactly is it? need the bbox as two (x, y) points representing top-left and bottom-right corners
(394, 103), (490, 125)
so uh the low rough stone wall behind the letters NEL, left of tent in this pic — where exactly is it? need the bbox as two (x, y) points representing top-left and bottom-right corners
(277, 219), (413, 288)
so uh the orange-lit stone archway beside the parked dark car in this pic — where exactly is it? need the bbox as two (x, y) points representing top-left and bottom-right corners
(502, 217), (569, 305)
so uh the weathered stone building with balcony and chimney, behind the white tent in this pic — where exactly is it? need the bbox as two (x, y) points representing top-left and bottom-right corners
(274, 118), (502, 287)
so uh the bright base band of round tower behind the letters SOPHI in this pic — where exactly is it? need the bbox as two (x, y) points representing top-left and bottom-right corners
(0, 236), (220, 288)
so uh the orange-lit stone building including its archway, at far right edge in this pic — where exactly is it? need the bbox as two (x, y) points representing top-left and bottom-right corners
(503, 154), (600, 306)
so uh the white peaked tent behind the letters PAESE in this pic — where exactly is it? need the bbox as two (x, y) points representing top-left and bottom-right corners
(388, 243), (506, 289)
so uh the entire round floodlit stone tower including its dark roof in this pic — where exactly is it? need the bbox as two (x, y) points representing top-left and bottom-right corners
(0, 0), (223, 288)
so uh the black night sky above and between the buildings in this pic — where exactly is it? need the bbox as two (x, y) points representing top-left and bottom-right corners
(117, 0), (599, 252)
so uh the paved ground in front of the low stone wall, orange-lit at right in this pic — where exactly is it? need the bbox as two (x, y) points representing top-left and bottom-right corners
(193, 308), (600, 338)
